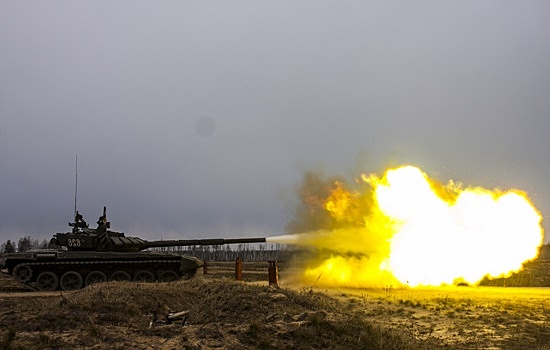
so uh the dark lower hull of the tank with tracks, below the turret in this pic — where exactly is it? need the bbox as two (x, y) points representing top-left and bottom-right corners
(2, 250), (202, 291)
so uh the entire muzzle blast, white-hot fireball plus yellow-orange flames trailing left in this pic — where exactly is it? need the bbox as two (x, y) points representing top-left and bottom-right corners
(299, 166), (543, 286)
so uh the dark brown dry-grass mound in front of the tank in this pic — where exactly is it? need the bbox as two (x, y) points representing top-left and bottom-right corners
(0, 276), (432, 349)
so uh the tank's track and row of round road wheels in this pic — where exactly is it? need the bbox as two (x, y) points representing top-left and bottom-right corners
(11, 259), (196, 291)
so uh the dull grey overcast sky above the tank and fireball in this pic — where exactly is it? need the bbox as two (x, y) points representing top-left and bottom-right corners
(0, 0), (550, 243)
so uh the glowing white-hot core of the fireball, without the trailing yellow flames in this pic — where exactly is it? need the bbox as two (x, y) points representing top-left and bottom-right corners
(380, 166), (543, 286)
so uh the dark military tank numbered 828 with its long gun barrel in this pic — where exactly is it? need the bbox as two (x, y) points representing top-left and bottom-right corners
(0, 207), (265, 291)
